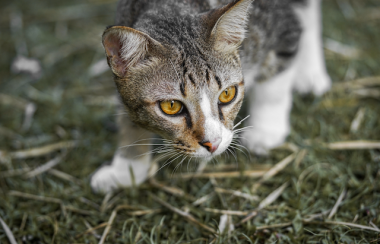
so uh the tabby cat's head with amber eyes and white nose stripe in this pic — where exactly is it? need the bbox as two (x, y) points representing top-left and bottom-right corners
(103, 0), (252, 157)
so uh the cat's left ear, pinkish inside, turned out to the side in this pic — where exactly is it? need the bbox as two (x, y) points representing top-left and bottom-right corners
(103, 26), (163, 77)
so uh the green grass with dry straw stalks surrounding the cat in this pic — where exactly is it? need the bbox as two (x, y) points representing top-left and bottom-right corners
(0, 0), (380, 244)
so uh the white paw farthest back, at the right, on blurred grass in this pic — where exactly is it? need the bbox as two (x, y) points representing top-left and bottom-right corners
(294, 71), (331, 96)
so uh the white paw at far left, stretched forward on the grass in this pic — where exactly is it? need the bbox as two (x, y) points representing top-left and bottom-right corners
(91, 154), (150, 193)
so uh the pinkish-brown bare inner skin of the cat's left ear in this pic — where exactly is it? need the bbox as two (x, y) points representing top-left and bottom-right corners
(103, 33), (127, 76)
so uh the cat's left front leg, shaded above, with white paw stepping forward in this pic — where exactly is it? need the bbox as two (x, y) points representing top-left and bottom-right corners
(91, 111), (153, 193)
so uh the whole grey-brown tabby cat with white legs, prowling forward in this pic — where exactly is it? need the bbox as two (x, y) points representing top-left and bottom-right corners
(91, 0), (330, 192)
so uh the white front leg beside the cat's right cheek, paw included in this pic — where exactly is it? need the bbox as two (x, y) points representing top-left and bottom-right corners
(242, 67), (295, 154)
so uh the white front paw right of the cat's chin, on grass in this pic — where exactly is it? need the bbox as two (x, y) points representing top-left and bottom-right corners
(242, 129), (289, 155)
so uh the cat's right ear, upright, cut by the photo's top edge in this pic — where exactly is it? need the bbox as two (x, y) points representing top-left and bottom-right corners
(202, 0), (253, 52)
